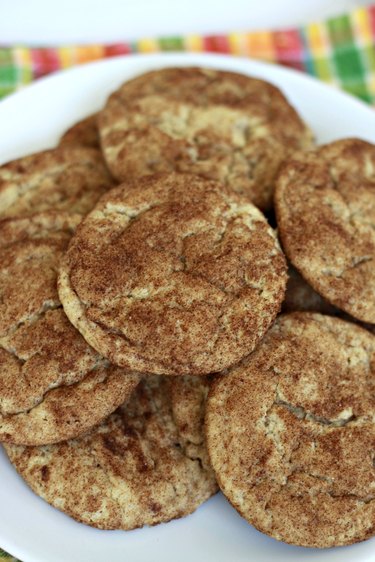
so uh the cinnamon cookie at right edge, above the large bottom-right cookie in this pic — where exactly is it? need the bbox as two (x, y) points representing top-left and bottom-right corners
(275, 139), (375, 323)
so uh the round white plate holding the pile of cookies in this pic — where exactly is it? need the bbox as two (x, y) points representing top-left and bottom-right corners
(0, 54), (375, 562)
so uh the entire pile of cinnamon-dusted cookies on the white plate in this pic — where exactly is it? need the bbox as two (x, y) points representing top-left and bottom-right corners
(0, 68), (375, 547)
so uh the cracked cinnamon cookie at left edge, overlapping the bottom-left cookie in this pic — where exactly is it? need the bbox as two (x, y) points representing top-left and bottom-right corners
(0, 211), (140, 445)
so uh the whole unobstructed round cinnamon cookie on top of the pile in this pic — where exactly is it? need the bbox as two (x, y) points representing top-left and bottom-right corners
(59, 174), (286, 375)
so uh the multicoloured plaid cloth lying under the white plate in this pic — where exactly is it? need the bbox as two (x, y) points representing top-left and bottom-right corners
(0, 4), (375, 562)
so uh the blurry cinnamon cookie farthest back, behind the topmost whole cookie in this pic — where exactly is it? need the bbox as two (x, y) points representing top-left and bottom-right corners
(99, 68), (312, 209)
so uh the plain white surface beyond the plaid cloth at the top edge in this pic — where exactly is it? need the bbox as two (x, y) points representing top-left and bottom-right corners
(0, 0), (371, 46)
